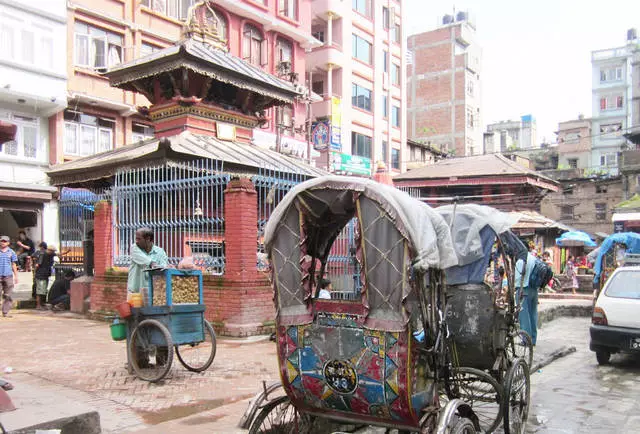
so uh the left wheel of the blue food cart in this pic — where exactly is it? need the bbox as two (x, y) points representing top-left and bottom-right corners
(129, 319), (173, 382)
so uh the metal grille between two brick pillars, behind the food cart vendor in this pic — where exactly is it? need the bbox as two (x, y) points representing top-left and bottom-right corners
(113, 159), (230, 275)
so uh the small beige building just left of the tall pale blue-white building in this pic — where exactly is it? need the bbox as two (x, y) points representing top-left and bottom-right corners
(556, 115), (591, 174)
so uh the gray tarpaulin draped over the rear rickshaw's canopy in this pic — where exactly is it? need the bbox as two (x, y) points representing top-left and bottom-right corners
(435, 204), (520, 266)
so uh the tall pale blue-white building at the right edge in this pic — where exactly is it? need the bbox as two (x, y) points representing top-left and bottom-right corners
(591, 29), (640, 174)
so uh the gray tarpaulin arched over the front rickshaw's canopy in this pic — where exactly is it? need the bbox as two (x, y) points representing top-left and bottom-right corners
(265, 176), (458, 270)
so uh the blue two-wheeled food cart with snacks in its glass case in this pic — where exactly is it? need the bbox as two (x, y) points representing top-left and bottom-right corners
(127, 269), (216, 382)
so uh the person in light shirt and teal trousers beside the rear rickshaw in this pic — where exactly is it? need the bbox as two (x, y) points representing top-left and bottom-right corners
(515, 252), (538, 345)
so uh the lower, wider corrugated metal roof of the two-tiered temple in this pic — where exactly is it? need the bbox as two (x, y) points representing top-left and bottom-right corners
(47, 131), (327, 185)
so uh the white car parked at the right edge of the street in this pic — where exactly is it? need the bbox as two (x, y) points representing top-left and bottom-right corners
(589, 266), (640, 365)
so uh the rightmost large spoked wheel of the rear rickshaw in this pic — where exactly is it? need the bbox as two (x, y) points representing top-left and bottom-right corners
(503, 359), (531, 434)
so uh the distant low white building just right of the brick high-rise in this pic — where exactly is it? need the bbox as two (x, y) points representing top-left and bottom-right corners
(485, 115), (539, 153)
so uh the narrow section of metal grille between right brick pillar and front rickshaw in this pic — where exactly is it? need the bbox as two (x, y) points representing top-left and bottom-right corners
(251, 166), (307, 270)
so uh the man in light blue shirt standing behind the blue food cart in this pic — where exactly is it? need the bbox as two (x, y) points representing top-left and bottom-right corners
(127, 228), (168, 293)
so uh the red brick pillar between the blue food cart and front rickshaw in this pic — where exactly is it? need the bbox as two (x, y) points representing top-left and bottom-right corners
(224, 178), (258, 280)
